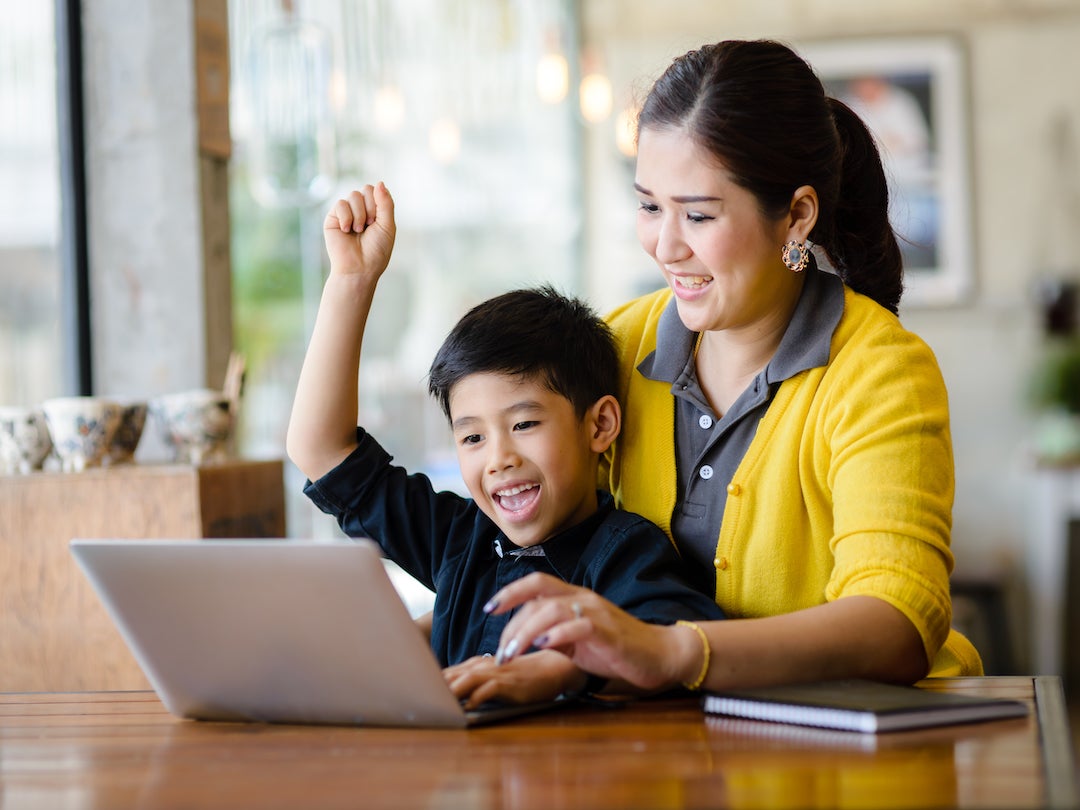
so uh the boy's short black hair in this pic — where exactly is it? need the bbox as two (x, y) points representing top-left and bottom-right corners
(428, 285), (619, 419)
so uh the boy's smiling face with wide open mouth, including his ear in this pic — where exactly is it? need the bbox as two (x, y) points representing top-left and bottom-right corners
(450, 373), (617, 546)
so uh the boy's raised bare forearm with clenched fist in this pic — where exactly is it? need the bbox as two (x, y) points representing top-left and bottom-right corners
(285, 183), (396, 481)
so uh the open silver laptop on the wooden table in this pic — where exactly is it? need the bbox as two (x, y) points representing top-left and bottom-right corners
(70, 539), (564, 728)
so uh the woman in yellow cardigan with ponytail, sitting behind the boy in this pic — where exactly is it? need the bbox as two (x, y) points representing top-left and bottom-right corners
(489, 41), (982, 689)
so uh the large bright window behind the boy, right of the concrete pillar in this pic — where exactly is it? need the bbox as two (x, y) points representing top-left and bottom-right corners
(230, 0), (583, 546)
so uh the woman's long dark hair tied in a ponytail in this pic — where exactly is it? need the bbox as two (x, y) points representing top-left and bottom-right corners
(638, 40), (903, 312)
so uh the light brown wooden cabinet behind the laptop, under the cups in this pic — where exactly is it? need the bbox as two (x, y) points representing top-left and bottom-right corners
(0, 460), (285, 692)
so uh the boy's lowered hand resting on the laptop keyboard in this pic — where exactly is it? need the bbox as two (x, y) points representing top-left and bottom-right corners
(443, 650), (585, 708)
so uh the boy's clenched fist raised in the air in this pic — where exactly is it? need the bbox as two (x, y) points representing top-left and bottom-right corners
(323, 183), (397, 281)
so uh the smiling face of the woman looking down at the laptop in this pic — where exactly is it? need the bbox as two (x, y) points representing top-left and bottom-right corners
(634, 127), (801, 332)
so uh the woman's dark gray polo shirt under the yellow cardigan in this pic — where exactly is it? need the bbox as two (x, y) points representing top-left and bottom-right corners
(637, 267), (843, 593)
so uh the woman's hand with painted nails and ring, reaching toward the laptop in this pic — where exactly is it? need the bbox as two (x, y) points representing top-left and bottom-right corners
(485, 573), (686, 691)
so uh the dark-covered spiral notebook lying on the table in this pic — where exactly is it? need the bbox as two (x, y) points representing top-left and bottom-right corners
(702, 679), (1028, 733)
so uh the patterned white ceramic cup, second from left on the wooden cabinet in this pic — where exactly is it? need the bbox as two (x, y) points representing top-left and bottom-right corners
(41, 396), (120, 472)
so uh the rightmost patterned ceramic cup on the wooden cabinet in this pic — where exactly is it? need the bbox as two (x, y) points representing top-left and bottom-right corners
(150, 388), (233, 464)
